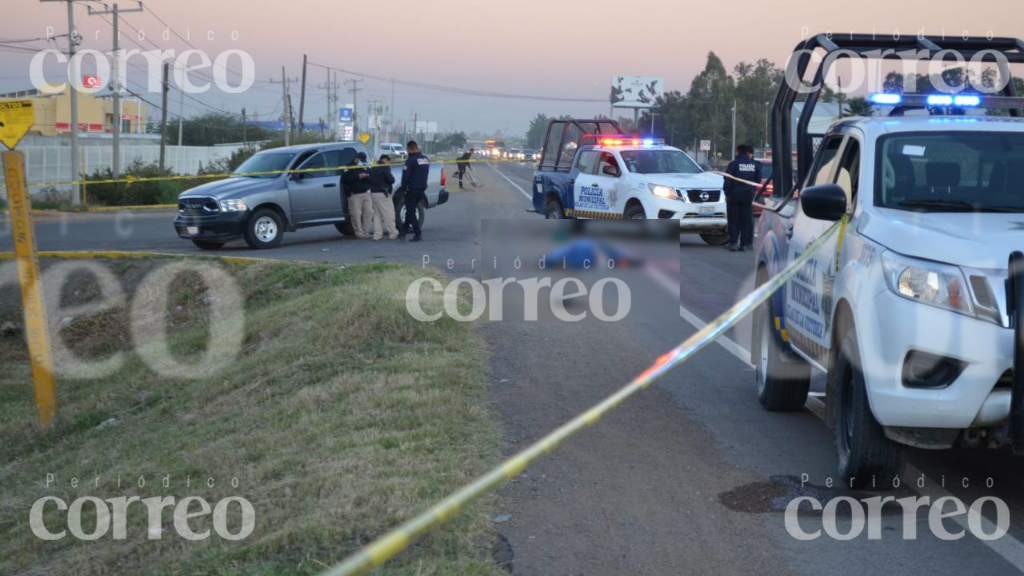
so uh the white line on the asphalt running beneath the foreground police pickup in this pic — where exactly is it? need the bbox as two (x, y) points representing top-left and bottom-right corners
(647, 269), (1024, 573)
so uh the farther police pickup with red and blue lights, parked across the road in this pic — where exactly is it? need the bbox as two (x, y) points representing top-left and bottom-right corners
(534, 119), (729, 245)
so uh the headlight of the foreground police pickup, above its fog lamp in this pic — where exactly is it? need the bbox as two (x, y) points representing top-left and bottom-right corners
(882, 252), (975, 316)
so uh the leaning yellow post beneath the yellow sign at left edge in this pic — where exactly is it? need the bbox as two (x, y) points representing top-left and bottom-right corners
(3, 152), (57, 428)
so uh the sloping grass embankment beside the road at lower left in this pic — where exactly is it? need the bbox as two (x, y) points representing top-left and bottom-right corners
(0, 259), (503, 575)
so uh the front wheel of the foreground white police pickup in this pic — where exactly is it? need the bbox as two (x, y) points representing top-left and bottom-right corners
(828, 329), (906, 490)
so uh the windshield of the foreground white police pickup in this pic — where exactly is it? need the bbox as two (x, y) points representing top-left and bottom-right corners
(874, 132), (1024, 212)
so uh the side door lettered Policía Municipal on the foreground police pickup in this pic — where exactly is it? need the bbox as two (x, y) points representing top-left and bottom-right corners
(784, 134), (847, 366)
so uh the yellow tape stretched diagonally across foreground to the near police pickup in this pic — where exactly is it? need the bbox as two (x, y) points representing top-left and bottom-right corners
(321, 216), (849, 576)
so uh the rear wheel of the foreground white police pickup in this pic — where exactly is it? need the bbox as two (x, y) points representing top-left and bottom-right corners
(754, 295), (811, 412)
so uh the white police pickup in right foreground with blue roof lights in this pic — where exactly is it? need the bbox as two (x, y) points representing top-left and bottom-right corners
(752, 89), (1024, 488)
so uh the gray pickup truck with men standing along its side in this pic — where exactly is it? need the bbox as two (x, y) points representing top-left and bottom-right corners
(174, 142), (449, 250)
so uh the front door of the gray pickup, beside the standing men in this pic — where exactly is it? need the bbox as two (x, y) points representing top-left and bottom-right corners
(288, 148), (355, 223)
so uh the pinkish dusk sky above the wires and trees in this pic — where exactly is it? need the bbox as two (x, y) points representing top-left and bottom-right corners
(0, 0), (1024, 134)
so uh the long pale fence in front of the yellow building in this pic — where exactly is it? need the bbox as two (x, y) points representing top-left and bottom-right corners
(0, 145), (241, 194)
